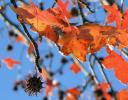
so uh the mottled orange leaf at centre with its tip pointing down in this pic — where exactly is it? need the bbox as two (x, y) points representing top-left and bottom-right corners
(59, 26), (88, 61)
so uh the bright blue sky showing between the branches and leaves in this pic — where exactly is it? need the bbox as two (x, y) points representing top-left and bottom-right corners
(0, 0), (128, 100)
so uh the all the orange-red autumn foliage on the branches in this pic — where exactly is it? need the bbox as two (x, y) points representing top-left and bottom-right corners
(2, 0), (128, 100)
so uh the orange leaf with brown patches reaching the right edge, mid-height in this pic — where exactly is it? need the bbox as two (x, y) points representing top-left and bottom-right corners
(78, 24), (128, 52)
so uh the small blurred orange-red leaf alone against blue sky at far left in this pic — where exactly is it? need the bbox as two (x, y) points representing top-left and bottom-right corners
(3, 58), (20, 69)
